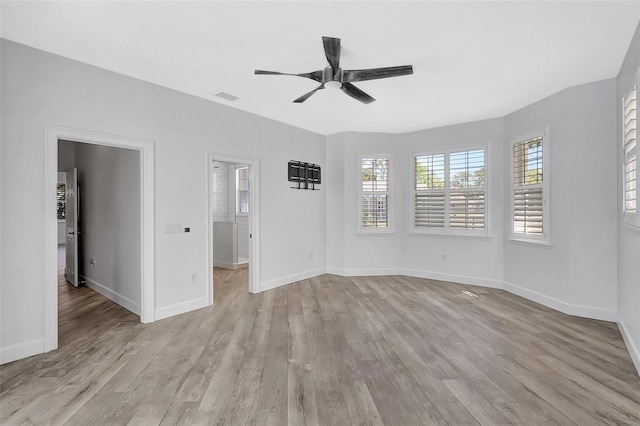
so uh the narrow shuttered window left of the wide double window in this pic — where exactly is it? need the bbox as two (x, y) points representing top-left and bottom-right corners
(359, 155), (391, 231)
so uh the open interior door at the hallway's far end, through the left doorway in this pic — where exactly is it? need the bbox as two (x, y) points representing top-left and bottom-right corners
(64, 168), (79, 287)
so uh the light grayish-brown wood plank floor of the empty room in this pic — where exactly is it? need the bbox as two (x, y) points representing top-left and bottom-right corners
(0, 269), (640, 426)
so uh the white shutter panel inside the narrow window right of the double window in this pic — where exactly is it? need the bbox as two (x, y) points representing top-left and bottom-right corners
(513, 137), (545, 236)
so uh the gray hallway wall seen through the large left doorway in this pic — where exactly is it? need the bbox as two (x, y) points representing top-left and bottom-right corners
(75, 143), (142, 315)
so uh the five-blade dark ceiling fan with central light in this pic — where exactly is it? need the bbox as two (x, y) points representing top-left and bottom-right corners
(255, 37), (413, 104)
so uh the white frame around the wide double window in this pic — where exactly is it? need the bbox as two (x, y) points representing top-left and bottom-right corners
(409, 144), (490, 238)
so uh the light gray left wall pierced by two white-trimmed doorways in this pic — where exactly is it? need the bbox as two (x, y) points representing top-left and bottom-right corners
(0, 40), (326, 362)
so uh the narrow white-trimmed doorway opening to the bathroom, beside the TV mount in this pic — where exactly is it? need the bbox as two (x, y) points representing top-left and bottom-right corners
(207, 153), (259, 305)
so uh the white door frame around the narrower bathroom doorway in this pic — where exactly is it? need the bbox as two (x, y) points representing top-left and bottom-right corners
(206, 152), (260, 305)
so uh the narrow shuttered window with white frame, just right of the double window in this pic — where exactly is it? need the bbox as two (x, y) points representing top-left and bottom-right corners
(511, 130), (549, 243)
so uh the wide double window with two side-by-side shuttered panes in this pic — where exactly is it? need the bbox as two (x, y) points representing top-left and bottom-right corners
(413, 148), (487, 234)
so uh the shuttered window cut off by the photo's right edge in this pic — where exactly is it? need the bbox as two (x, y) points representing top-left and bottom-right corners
(622, 86), (640, 226)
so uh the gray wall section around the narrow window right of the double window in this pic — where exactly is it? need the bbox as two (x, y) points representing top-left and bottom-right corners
(503, 79), (618, 321)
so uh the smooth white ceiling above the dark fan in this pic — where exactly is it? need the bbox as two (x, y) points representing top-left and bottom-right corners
(0, 0), (640, 134)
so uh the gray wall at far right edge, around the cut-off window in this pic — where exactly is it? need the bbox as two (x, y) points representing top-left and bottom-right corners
(610, 21), (640, 371)
